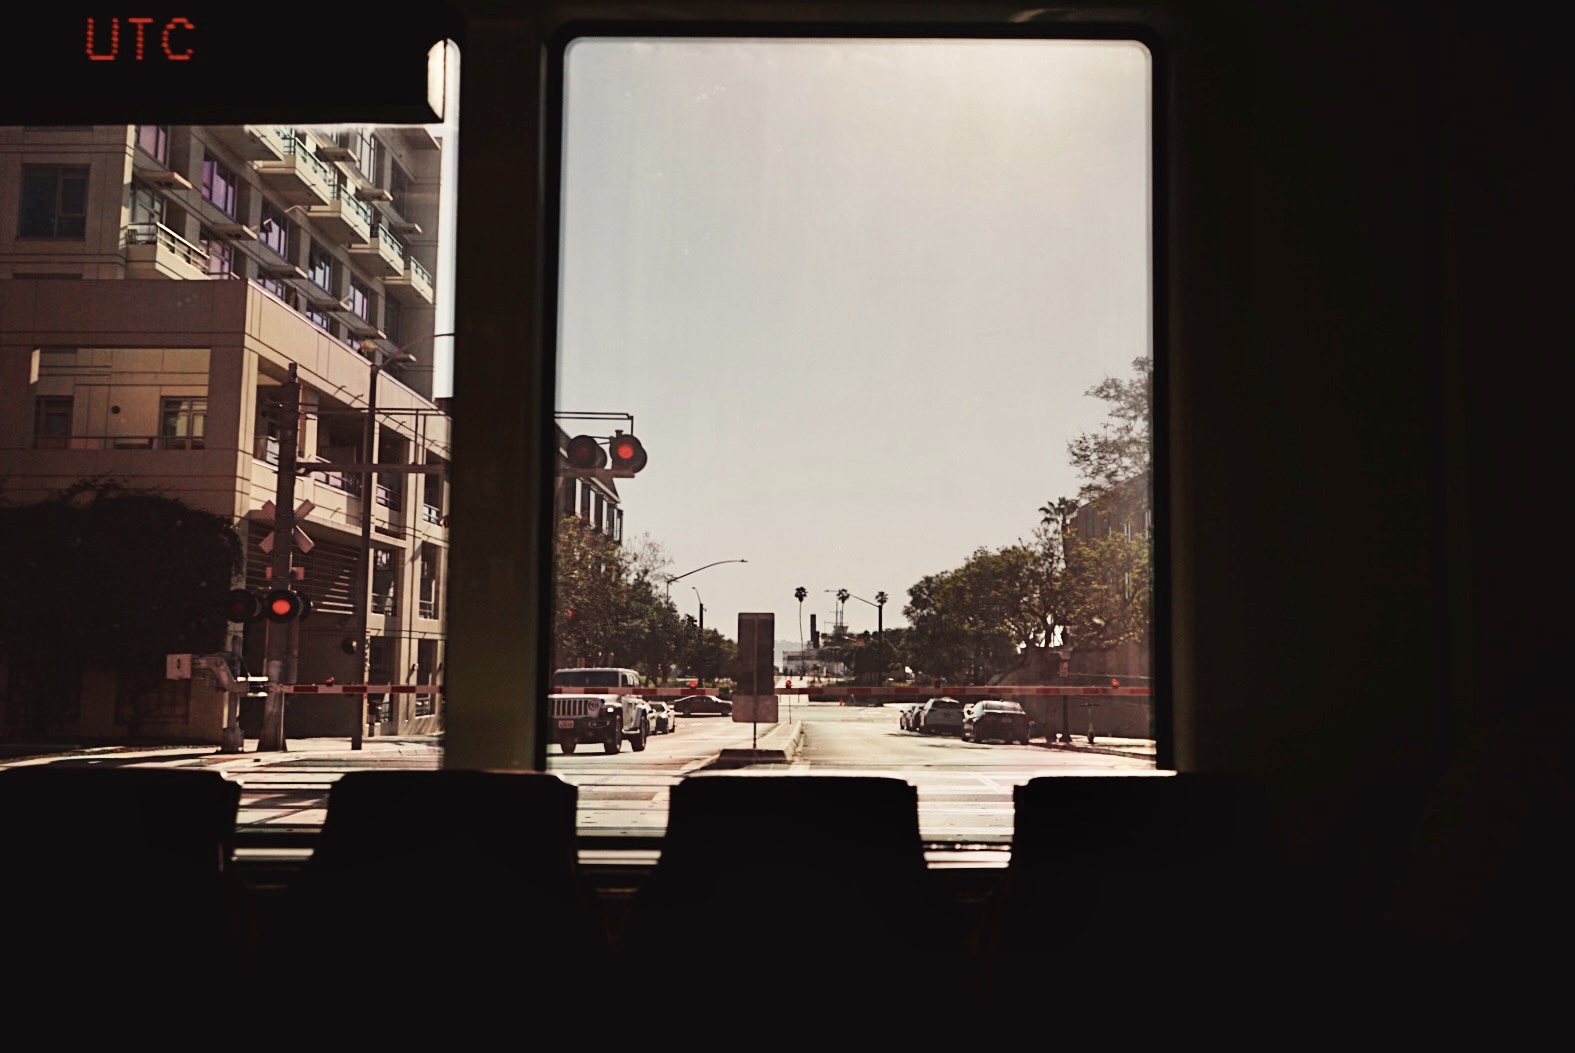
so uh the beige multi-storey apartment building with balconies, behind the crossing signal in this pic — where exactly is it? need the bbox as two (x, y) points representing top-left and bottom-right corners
(0, 124), (450, 741)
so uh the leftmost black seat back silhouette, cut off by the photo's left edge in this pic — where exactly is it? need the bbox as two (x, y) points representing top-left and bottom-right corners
(0, 763), (248, 1048)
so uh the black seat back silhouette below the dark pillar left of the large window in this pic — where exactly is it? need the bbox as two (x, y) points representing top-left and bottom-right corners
(263, 770), (608, 1048)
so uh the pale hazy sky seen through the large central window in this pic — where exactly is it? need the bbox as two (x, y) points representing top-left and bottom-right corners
(558, 39), (1150, 641)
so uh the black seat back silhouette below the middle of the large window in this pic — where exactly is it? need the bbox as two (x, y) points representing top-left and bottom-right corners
(616, 774), (942, 1050)
